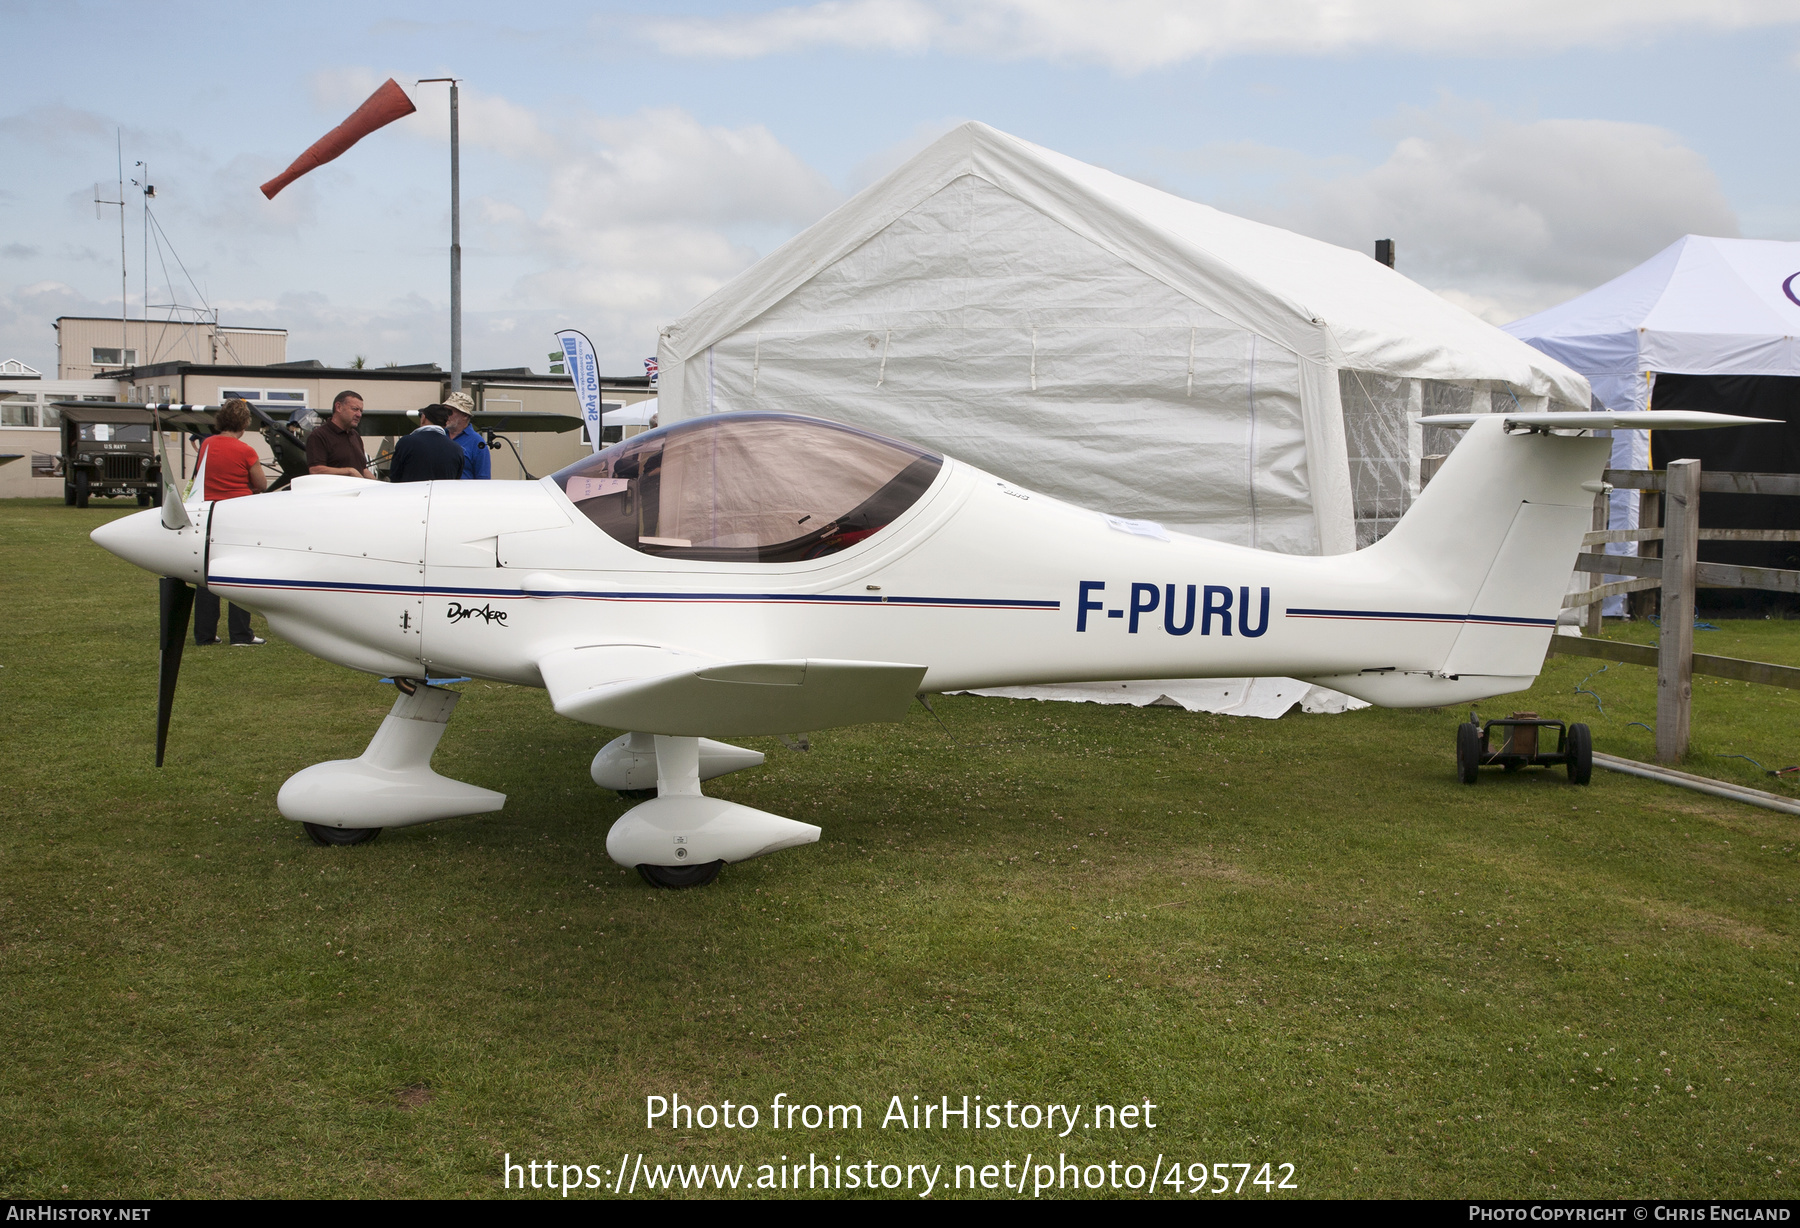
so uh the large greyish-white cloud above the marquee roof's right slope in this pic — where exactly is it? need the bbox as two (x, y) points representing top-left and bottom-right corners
(1228, 119), (1737, 321)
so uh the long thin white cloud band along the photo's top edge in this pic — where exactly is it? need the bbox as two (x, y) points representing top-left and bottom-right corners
(641, 0), (1800, 72)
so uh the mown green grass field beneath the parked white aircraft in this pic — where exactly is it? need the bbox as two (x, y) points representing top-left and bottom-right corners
(0, 501), (1800, 1197)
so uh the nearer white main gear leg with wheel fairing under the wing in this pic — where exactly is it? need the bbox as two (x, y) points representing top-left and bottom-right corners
(612, 733), (819, 888)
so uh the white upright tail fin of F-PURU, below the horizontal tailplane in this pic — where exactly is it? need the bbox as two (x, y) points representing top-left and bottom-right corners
(1370, 414), (1611, 677)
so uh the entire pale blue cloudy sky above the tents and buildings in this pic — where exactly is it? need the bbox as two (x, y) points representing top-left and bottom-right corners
(0, 0), (1800, 375)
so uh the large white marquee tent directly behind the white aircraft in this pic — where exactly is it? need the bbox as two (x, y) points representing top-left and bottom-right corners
(657, 122), (1589, 713)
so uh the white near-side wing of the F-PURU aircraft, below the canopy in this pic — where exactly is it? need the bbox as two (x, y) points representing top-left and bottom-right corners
(538, 645), (925, 738)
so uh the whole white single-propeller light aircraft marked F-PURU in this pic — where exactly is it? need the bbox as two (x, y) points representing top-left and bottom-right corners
(94, 412), (1762, 886)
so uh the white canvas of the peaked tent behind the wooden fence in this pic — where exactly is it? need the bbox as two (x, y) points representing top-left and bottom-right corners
(1507, 234), (1800, 601)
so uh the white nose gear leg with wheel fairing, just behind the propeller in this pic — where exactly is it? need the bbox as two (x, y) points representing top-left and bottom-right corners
(275, 682), (506, 844)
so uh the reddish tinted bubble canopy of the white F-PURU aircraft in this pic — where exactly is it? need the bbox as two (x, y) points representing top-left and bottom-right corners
(553, 412), (943, 564)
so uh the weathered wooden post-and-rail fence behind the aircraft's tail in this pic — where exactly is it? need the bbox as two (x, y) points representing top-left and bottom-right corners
(1550, 461), (1800, 763)
